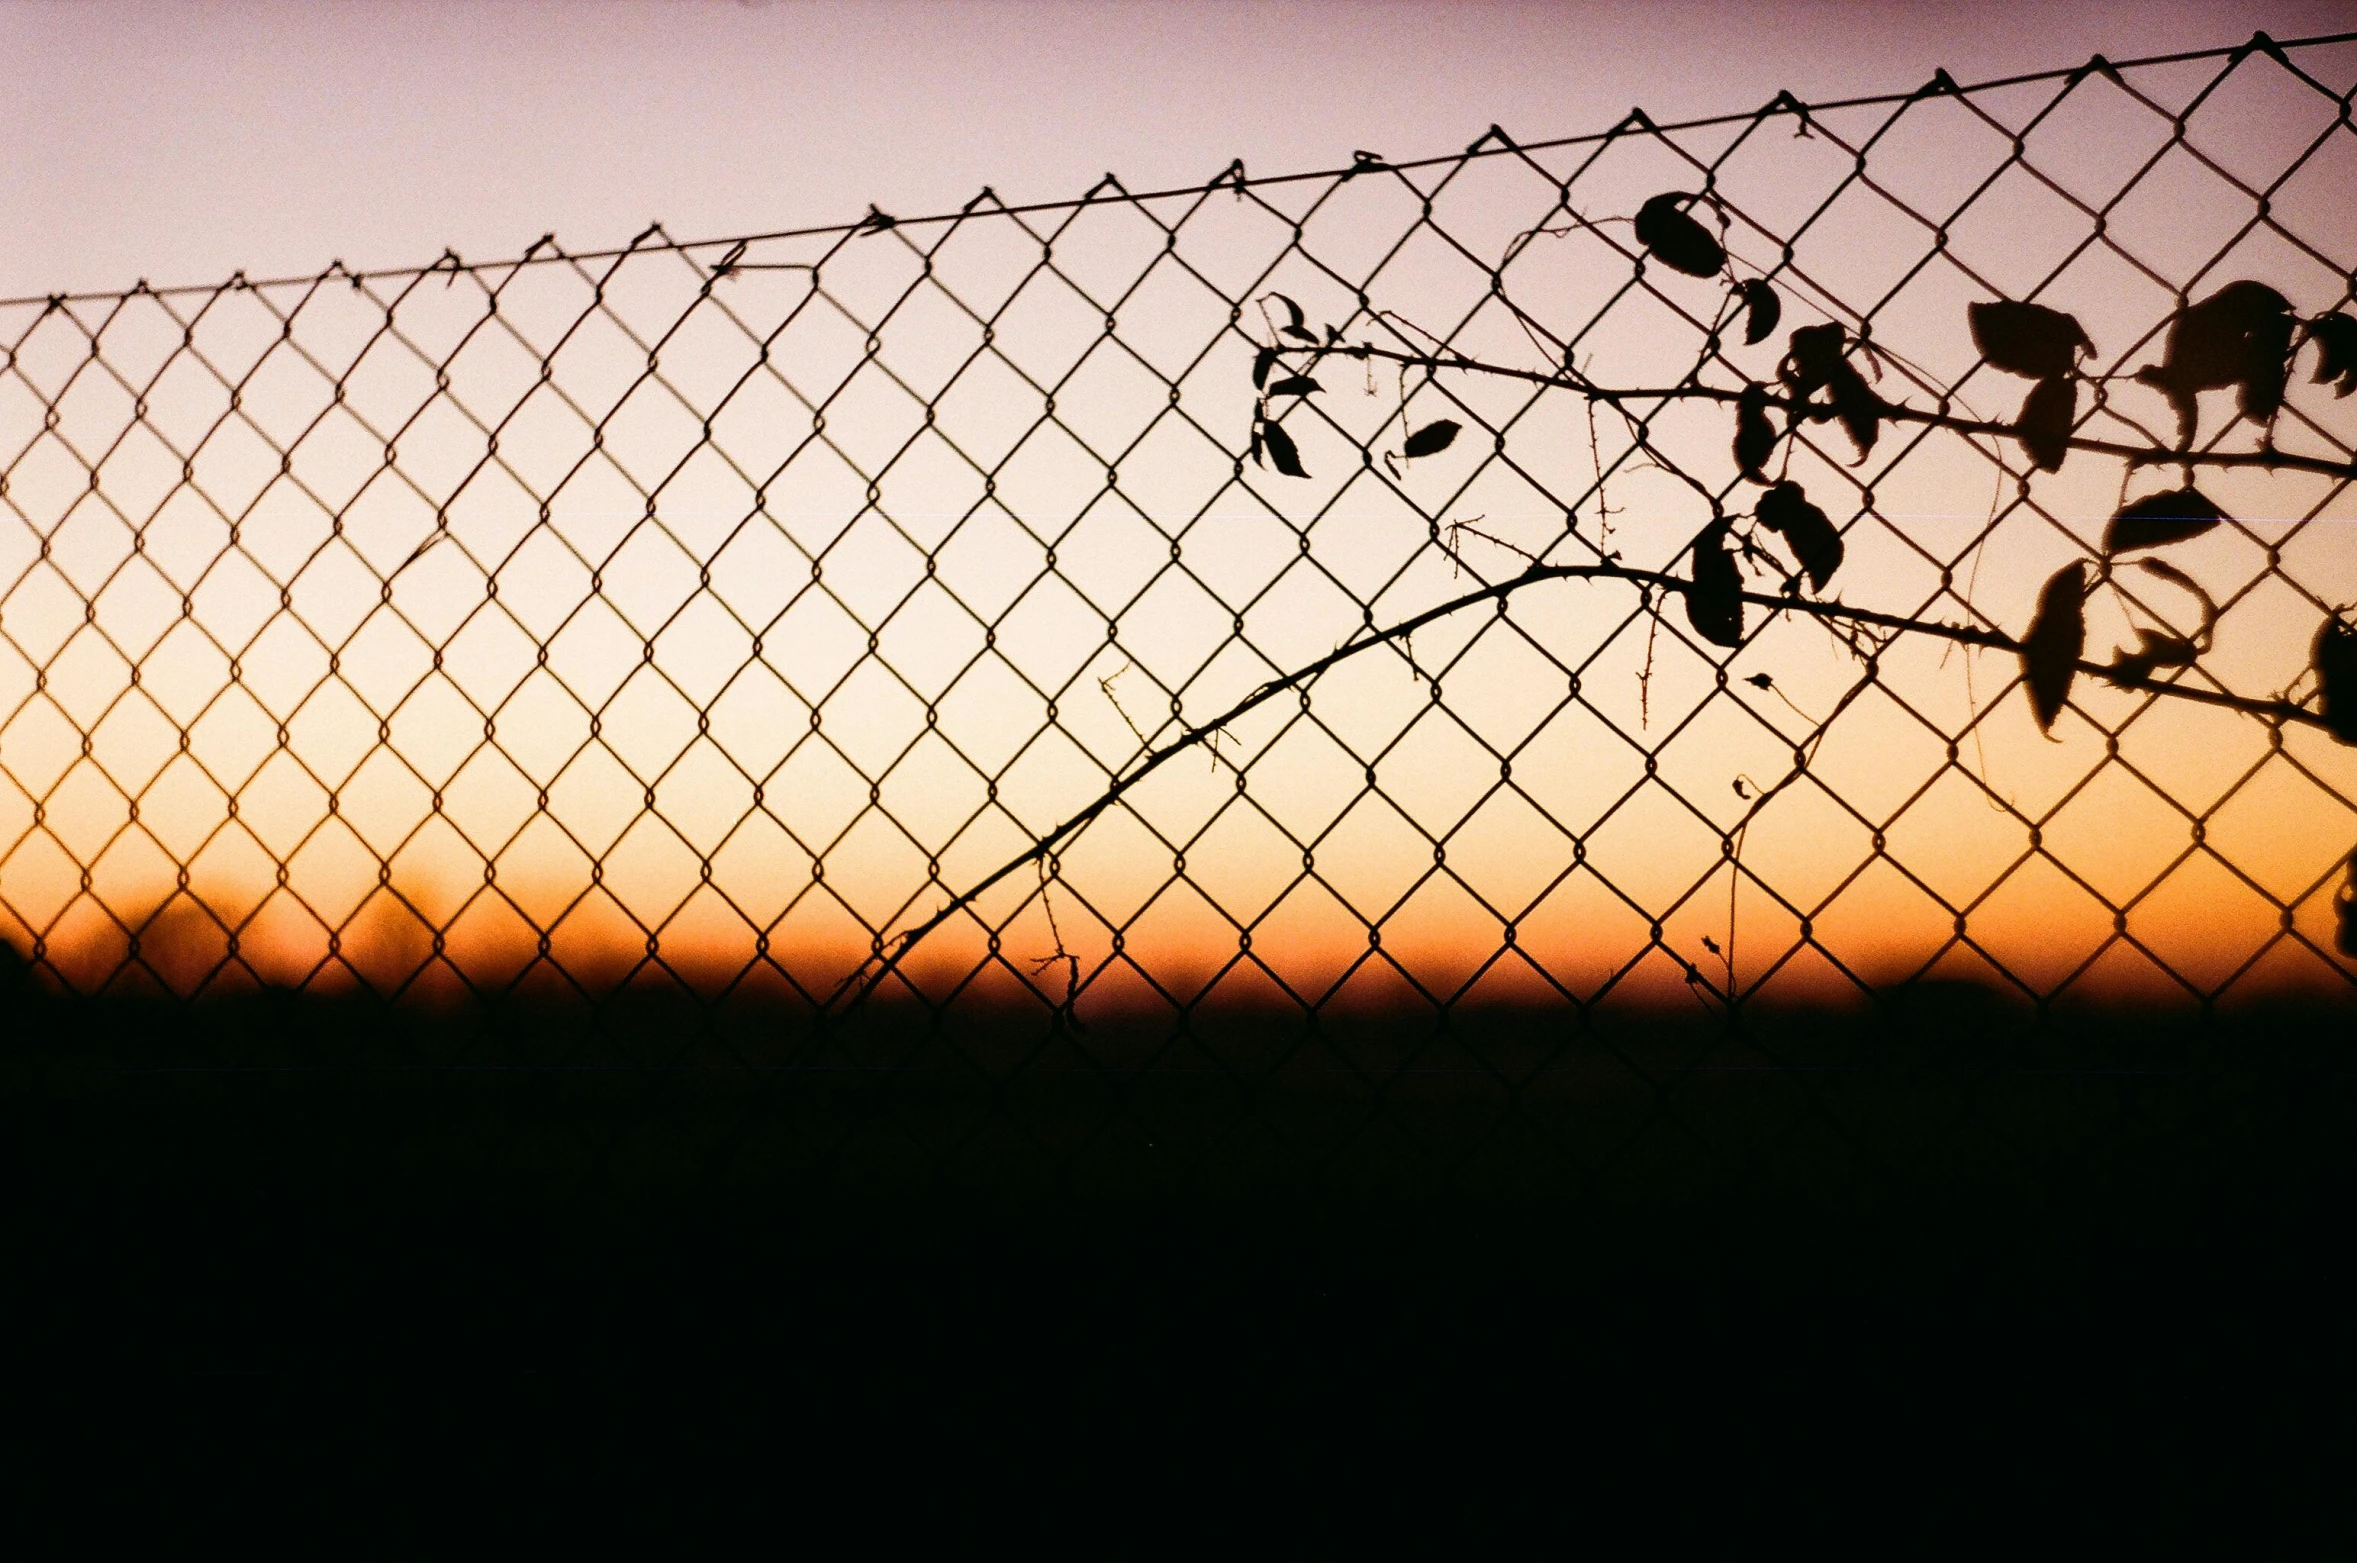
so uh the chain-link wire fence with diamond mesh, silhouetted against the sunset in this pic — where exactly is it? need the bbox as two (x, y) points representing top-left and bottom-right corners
(0, 38), (2357, 1216)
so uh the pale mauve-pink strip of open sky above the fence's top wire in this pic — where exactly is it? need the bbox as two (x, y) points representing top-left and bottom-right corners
(0, 0), (2357, 297)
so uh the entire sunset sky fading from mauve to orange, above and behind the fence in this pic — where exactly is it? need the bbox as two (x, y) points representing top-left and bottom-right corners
(0, 5), (2357, 1013)
